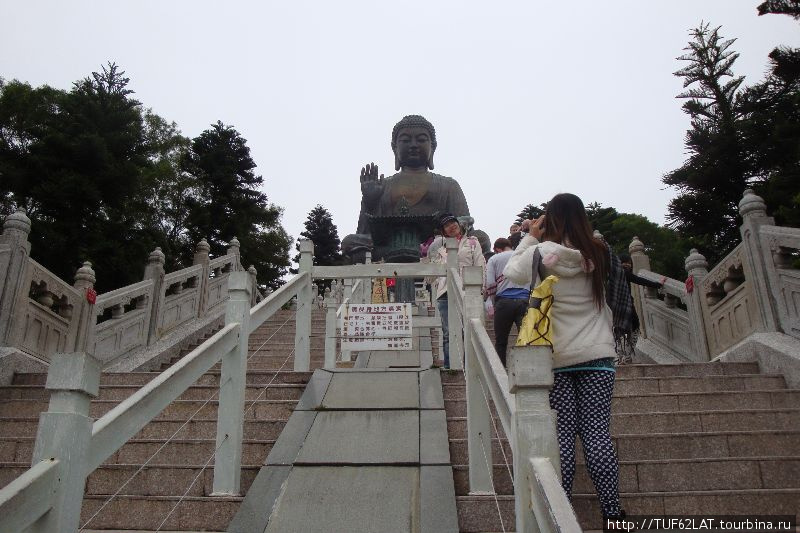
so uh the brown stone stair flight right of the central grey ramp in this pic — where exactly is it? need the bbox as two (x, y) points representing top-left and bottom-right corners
(442, 340), (800, 533)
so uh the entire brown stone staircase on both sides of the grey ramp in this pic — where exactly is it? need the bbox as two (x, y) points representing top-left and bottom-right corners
(0, 311), (800, 533)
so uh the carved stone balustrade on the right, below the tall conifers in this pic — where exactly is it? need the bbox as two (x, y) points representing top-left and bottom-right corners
(629, 190), (800, 362)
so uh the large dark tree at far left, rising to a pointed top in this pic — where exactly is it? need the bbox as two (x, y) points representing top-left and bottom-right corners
(0, 64), (159, 290)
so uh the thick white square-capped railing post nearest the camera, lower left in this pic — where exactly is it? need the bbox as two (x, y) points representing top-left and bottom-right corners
(28, 352), (100, 533)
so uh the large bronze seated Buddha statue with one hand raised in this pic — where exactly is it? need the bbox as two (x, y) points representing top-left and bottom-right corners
(342, 115), (472, 262)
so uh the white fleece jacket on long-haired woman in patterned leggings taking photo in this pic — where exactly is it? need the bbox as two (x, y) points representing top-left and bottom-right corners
(503, 235), (616, 368)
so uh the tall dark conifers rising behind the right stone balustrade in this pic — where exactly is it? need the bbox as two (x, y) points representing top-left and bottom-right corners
(663, 17), (800, 264)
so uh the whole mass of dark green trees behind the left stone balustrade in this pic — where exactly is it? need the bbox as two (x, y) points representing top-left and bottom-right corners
(0, 63), (291, 292)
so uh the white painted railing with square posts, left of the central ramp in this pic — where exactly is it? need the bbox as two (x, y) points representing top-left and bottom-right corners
(0, 241), (313, 533)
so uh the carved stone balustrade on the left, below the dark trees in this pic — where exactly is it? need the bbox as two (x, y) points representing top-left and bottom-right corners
(0, 210), (260, 376)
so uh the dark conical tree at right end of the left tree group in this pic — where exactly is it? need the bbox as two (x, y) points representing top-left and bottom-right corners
(181, 121), (291, 288)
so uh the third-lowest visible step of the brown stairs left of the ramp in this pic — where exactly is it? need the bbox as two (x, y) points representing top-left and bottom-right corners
(0, 437), (275, 466)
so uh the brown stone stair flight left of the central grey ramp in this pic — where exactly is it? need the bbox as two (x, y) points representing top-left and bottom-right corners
(0, 311), (325, 531)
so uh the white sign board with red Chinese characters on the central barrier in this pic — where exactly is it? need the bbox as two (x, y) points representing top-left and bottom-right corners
(339, 303), (411, 351)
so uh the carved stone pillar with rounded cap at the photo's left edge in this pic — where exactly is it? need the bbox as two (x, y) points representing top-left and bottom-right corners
(0, 208), (31, 346)
